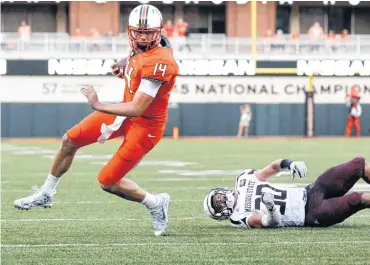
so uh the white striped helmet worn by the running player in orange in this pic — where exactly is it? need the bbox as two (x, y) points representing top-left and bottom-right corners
(127, 5), (163, 52)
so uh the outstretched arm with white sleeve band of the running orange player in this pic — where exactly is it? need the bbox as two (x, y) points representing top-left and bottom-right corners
(81, 79), (162, 117)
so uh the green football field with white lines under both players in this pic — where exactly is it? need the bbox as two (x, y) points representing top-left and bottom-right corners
(1, 139), (370, 265)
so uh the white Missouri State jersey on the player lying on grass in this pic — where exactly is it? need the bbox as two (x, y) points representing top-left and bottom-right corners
(230, 169), (307, 228)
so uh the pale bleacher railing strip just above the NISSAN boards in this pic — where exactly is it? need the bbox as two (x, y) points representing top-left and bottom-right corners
(0, 33), (370, 60)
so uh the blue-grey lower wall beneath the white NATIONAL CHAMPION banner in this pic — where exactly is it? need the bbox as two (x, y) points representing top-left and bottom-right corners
(1, 103), (370, 138)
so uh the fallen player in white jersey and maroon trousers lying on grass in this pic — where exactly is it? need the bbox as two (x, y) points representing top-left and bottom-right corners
(203, 157), (370, 228)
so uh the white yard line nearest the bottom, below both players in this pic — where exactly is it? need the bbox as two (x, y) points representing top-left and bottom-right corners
(1, 240), (370, 248)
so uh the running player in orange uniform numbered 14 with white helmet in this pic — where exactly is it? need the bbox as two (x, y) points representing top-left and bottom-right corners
(14, 5), (178, 236)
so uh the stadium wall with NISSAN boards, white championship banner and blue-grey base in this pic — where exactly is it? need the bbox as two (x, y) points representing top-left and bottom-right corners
(0, 60), (370, 137)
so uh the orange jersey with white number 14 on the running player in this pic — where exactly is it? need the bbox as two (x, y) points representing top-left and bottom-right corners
(123, 47), (179, 128)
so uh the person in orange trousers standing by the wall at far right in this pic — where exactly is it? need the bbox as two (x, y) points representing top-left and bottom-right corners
(345, 85), (362, 136)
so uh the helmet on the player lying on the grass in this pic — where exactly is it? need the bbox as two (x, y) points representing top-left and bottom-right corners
(203, 188), (235, 220)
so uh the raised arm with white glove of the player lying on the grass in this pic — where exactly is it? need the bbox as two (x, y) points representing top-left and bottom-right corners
(256, 159), (307, 181)
